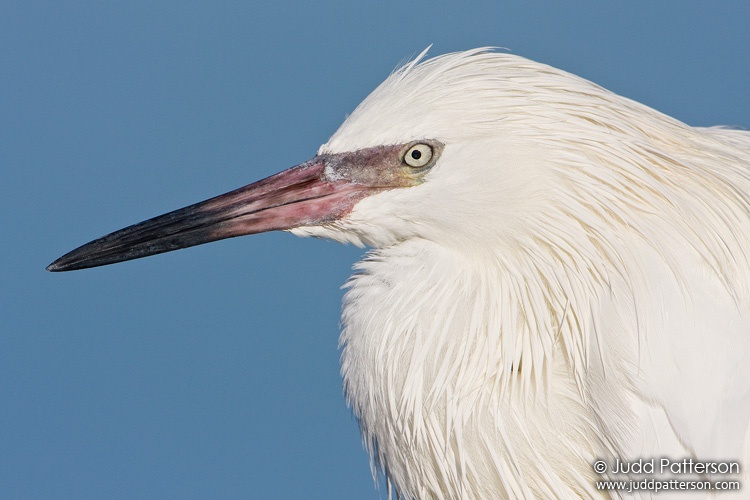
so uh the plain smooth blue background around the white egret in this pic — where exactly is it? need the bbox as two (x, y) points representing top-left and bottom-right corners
(0, 0), (750, 499)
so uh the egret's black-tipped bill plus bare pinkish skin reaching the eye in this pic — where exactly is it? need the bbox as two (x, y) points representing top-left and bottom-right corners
(47, 142), (434, 271)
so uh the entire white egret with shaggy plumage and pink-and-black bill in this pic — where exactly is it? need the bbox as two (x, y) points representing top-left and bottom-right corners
(49, 49), (750, 499)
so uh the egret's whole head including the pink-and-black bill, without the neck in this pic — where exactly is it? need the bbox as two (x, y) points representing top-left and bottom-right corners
(48, 49), (636, 271)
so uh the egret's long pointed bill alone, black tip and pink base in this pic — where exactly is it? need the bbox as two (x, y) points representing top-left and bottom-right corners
(47, 157), (373, 271)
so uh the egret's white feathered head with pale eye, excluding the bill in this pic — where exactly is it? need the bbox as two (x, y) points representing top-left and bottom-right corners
(300, 49), (552, 249)
